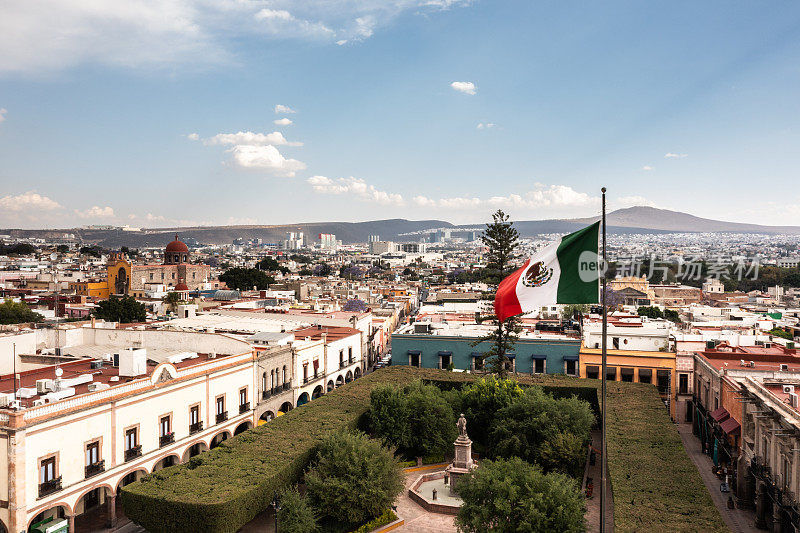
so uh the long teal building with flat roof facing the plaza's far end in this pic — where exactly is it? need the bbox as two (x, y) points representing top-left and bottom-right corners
(392, 333), (581, 376)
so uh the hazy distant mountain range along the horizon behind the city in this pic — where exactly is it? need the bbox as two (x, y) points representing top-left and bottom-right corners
(6, 206), (800, 248)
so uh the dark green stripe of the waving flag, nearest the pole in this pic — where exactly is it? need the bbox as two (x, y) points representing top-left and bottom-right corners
(556, 222), (600, 304)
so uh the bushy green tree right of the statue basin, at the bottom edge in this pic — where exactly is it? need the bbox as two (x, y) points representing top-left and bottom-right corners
(456, 457), (586, 533)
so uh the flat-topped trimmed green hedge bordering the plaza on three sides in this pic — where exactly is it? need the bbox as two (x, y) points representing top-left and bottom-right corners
(120, 366), (727, 533)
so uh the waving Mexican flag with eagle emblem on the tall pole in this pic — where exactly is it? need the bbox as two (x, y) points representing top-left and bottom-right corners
(494, 222), (600, 320)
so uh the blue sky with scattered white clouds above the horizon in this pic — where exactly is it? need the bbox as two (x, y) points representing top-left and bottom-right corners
(0, 0), (800, 227)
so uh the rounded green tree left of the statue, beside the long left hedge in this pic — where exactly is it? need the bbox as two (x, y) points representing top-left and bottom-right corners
(305, 432), (404, 526)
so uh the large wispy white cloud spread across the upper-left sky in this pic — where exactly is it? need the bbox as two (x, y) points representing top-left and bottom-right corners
(0, 0), (471, 73)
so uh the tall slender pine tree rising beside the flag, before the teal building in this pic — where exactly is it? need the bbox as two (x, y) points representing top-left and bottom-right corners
(473, 209), (522, 378)
